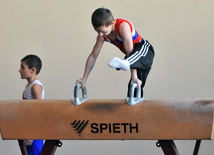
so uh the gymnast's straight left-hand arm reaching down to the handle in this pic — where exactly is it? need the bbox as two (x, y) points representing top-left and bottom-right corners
(76, 35), (104, 88)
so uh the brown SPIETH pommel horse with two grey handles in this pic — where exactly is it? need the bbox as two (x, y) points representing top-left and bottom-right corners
(0, 84), (214, 155)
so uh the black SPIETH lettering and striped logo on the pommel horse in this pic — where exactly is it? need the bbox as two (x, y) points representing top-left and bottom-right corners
(70, 120), (138, 135)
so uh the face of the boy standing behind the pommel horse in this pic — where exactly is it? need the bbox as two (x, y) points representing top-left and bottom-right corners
(19, 61), (33, 79)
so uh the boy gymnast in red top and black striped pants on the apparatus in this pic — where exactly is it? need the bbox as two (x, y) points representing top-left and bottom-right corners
(77, 8), (154, 97)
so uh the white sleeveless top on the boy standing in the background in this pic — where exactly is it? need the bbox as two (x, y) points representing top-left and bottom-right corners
(23, 80), (45, 99)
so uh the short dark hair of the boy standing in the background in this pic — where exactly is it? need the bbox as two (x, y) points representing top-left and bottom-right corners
(21, 54), (42, 74)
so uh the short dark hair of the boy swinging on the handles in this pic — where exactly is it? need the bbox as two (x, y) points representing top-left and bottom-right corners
(91, 8), (114, 28)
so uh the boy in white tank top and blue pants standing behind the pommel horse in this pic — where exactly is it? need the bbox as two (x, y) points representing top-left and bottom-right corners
(19, 55), (45, 155)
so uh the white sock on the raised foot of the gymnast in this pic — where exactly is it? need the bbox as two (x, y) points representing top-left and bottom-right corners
(108, 57), (130, 71)
